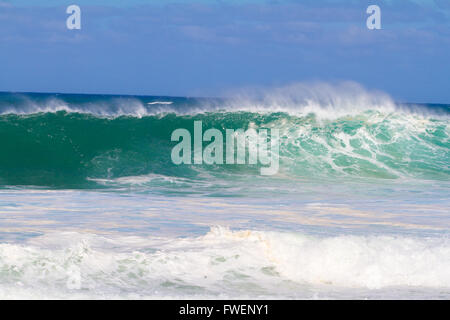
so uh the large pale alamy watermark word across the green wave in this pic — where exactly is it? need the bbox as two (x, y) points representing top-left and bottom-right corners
(171, 121), (279, 175)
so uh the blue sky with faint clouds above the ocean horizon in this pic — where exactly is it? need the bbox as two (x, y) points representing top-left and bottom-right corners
(0, 0), (450, 103)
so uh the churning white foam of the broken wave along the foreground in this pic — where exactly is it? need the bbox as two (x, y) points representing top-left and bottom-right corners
(0, 227), (450, 298)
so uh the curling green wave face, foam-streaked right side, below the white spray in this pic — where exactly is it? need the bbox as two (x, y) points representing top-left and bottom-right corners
(0, 110), (450, 187)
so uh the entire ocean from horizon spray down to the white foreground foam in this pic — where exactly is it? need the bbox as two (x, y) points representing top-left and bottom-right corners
(0, 85), (450, 299)
